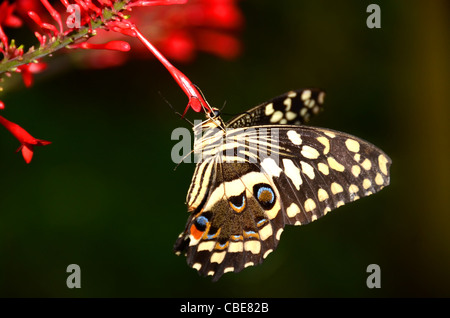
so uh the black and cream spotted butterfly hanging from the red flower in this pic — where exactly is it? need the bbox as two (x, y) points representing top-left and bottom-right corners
(174, 89), (391, 281)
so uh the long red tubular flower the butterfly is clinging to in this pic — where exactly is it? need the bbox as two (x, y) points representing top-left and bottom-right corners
(125, 23), (212, 116)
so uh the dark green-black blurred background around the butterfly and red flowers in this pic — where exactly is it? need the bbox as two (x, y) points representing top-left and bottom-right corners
(0, 0), (450, 297)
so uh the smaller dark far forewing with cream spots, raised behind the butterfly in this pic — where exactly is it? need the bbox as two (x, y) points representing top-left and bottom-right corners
(227, 89), (325, 128)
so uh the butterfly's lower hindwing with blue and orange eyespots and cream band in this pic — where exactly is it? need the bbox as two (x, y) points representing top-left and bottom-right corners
(175, 163), (284, 280)
